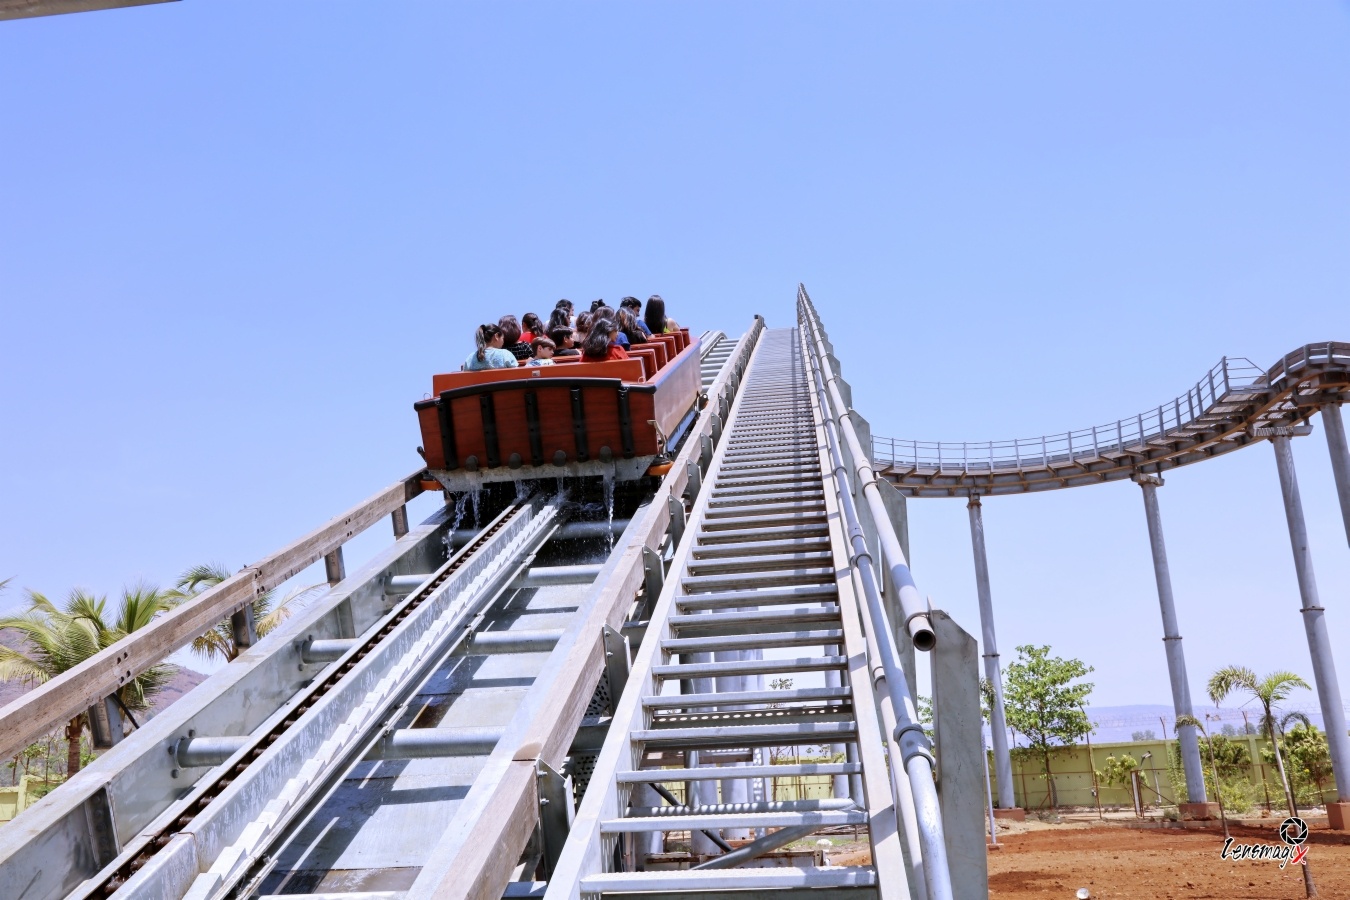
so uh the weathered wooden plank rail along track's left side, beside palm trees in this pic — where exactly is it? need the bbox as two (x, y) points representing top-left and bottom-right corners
(0, 471), (423, 758)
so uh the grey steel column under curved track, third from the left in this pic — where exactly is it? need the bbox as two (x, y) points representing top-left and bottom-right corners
(1270, 436), (1350, 801)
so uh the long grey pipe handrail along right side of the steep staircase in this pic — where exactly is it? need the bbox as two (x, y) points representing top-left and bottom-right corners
(797, 286), (952, 900)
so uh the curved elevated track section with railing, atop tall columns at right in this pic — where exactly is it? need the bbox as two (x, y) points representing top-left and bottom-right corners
(872, 341), (1350, 497)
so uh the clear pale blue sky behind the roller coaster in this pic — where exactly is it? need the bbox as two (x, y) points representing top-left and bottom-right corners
(0, 0), (1350, 706)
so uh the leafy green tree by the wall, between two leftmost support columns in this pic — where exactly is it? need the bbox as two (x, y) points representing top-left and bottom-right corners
(1003, 644), (1094, 806)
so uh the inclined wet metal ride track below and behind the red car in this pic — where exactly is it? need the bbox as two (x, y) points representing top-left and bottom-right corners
(0, 329), (763, 900)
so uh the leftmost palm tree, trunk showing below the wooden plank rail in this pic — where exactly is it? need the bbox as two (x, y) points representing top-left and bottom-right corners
(0, 584), (174, 777)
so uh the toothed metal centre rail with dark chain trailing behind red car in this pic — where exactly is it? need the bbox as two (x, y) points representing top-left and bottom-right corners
(96, 501), (556, 897)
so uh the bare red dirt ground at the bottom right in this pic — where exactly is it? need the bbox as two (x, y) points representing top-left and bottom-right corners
(990, 819), (1350, 900)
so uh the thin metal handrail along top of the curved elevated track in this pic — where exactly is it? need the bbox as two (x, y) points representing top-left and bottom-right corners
(871, 356), (1269, 474)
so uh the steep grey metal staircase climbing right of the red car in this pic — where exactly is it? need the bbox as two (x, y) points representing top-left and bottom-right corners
(545, 329), (910, 900)
